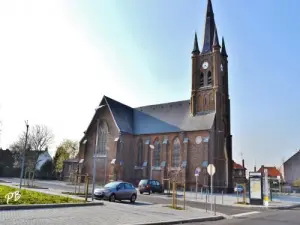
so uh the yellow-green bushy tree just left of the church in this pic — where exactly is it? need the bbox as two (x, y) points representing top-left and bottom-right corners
(53, 139), (78, 172)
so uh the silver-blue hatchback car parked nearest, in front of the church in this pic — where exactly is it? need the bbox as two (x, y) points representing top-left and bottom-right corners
(94, 181), (137, 203)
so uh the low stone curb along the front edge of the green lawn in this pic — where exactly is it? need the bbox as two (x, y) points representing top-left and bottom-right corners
(0, 202), (104, 211)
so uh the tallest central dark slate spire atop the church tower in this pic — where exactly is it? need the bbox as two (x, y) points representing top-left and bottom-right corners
(202, 0), (215, 54)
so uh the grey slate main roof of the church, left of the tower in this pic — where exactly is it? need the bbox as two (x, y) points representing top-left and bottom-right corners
(102, 96), (215, 135)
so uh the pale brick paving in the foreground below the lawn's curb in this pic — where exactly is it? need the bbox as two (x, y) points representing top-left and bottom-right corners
(0, 202), (220, 225)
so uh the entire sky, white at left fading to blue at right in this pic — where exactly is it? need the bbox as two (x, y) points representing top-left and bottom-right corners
(0, 0), (300, 172)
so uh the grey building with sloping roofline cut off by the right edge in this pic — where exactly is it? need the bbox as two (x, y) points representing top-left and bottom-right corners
(283, 150), (300, 185)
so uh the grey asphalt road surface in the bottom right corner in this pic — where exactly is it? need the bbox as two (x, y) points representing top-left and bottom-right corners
(188, 209), (300, 225)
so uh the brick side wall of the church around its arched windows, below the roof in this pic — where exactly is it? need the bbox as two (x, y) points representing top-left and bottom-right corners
(132, 131), (209, 188)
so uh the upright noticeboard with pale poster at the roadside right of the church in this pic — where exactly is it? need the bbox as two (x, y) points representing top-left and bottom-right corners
(249, 172), (263, 205)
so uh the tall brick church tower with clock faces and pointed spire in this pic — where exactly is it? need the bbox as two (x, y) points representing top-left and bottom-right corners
(191, 0), (232, 192)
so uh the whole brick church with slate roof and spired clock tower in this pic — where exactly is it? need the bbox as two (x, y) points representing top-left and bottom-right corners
(79, 0), (232, 191)
